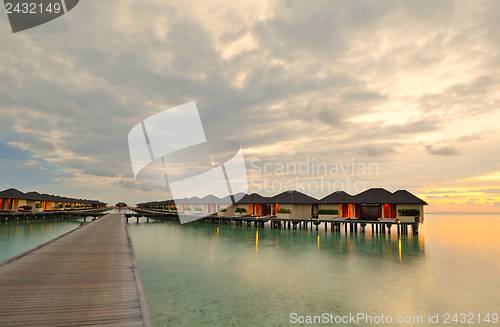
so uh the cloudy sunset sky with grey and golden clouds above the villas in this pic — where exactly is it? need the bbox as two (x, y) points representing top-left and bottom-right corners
(0, 0), (500, 212)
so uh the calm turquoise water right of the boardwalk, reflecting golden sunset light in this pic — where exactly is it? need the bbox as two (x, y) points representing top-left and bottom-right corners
(129, 215), (500, 326)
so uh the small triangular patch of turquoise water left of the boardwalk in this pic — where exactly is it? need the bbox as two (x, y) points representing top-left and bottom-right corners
(0, 219), (80, 262)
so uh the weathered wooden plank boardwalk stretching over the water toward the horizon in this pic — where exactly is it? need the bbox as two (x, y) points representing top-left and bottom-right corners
(0, 214), (151, 327)
